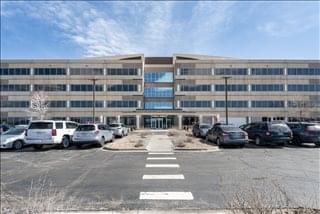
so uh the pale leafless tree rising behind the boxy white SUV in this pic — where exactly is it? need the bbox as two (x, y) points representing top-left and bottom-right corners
(28, 91), (49, 120)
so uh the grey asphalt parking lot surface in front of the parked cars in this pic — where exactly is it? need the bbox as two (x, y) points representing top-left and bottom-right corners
(1, 136), (320, 210)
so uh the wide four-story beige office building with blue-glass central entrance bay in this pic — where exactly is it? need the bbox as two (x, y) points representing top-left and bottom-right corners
(0, 54), (320, 128)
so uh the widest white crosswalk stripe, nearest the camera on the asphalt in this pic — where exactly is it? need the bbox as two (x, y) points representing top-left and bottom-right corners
(140, 192), (193, 200)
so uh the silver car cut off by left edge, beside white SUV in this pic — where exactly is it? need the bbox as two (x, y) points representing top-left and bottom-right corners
(0, 127), (26, 150)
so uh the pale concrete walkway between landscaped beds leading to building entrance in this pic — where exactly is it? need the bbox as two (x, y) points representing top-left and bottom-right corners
(147, 133), (173, 152)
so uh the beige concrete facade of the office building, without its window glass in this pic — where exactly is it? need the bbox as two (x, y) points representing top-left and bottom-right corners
(1, 54), (320, 128)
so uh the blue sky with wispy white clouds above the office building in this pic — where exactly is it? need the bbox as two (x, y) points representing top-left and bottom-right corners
(1, 1), (320, 59)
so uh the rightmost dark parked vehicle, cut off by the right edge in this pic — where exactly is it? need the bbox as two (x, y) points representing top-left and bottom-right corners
(287, 122), (320, 146)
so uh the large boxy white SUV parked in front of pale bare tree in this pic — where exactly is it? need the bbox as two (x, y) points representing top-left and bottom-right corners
(25, 120), (78, 149)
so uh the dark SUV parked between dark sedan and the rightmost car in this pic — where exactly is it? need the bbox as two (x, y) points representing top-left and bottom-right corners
(243, 121), (292, 146)
